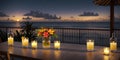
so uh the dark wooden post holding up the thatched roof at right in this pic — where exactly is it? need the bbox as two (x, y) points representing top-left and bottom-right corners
(110, 0), (114, 37)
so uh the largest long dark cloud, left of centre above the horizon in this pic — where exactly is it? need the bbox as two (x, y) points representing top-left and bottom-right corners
(24, 11), (60, 19)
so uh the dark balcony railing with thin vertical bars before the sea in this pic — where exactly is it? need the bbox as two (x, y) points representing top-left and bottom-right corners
(0, 27), (120, 47)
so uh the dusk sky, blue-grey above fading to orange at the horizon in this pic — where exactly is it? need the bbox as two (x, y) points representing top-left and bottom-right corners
(0, 0), (120, 20)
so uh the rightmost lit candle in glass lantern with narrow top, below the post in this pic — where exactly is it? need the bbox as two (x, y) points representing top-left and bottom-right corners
(110, 33), (117, 51)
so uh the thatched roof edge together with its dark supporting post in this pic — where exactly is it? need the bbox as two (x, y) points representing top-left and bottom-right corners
(94, 0), (120, 37)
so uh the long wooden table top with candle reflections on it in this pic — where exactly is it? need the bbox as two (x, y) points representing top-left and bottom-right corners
(0, 42), (120, 60)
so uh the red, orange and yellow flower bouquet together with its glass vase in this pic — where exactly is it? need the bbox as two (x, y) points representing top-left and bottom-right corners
(38, 28), (57, 48)
